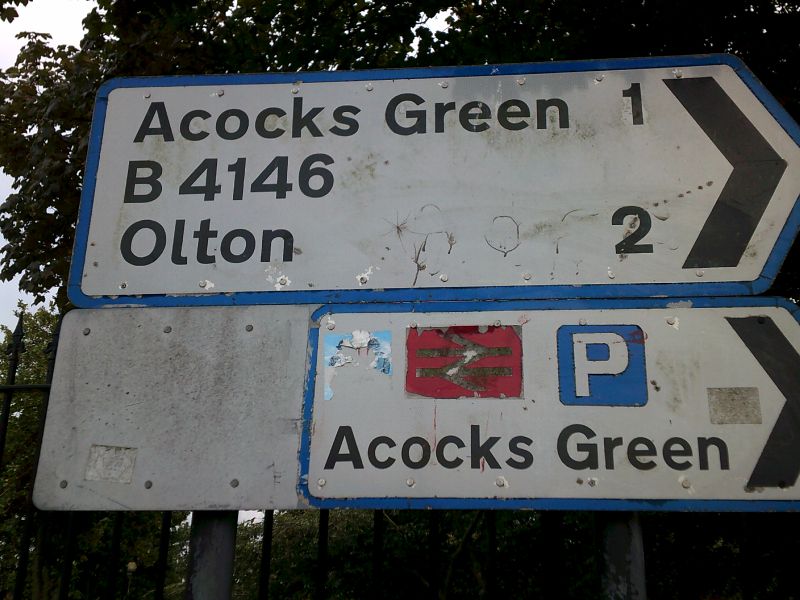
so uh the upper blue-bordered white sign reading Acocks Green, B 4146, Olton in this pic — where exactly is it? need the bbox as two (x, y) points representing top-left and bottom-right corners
(69, 56), (800, 306)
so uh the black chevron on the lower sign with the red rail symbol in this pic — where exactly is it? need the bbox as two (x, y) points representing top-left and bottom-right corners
(727, 317), (800, 488)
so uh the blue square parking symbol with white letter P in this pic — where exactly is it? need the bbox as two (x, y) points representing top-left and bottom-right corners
(556, 325), (647, 406)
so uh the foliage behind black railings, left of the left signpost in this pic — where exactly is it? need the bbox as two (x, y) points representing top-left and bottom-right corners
(0, 304), (188, 600)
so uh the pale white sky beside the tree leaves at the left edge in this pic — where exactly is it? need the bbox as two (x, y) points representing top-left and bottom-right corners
(0, 0), (95, 328)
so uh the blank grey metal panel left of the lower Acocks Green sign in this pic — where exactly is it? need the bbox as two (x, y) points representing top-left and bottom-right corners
(34, 306), (310, 510)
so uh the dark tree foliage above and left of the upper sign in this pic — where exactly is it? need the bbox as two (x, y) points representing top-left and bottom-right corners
(0, 0), (800, 305)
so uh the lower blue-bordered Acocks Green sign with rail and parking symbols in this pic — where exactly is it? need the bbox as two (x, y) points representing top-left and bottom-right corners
(300, 298), (800, 510)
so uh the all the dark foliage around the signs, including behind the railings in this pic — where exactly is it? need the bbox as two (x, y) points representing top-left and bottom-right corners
(0, 0), (800, 600)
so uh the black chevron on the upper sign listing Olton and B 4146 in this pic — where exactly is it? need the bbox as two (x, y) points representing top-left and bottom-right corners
(664, 77), (786, 269)
